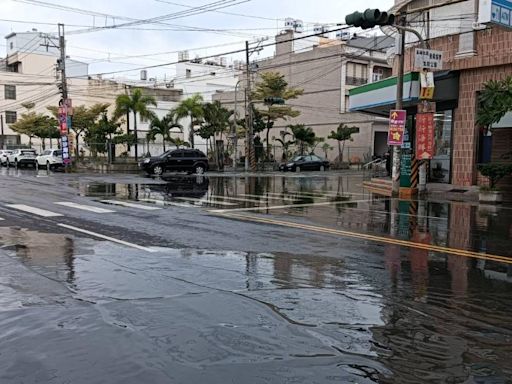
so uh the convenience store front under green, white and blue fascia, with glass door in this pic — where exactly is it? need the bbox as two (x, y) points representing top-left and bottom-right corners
(349, 72), (459, 183)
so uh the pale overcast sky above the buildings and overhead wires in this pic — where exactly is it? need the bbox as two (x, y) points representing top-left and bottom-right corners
(0, 0), (393, 78)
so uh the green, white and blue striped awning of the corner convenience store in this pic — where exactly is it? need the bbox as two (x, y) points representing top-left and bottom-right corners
(349, 71), (459, 116)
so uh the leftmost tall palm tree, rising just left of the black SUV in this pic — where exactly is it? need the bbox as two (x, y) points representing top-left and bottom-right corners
(116, 88), (156, 160)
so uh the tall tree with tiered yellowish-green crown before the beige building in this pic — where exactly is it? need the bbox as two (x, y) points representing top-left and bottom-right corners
(252, 72), (304, 157)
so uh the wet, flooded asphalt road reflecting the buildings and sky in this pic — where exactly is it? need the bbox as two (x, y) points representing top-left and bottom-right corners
(0, 169), (512, 384)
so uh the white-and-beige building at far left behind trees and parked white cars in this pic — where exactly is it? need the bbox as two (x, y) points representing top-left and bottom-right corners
(0, 30), (181, 154)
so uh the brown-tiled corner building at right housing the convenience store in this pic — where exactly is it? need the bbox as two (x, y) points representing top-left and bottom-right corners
(350, 0), (512, 187)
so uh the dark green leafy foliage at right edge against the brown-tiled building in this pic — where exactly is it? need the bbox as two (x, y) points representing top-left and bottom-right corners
(476, 76), (512, 128)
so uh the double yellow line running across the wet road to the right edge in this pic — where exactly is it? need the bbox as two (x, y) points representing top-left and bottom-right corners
(210, 211), (512, 264)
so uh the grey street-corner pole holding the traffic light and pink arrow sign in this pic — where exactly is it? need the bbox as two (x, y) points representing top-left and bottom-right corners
(391, 16), (405, 197)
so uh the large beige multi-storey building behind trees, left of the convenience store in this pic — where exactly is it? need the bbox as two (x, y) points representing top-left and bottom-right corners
(213, 30), (394, 163)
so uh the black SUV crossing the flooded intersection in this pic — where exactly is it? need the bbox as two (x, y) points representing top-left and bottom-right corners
(139, 149), (208, 176)
